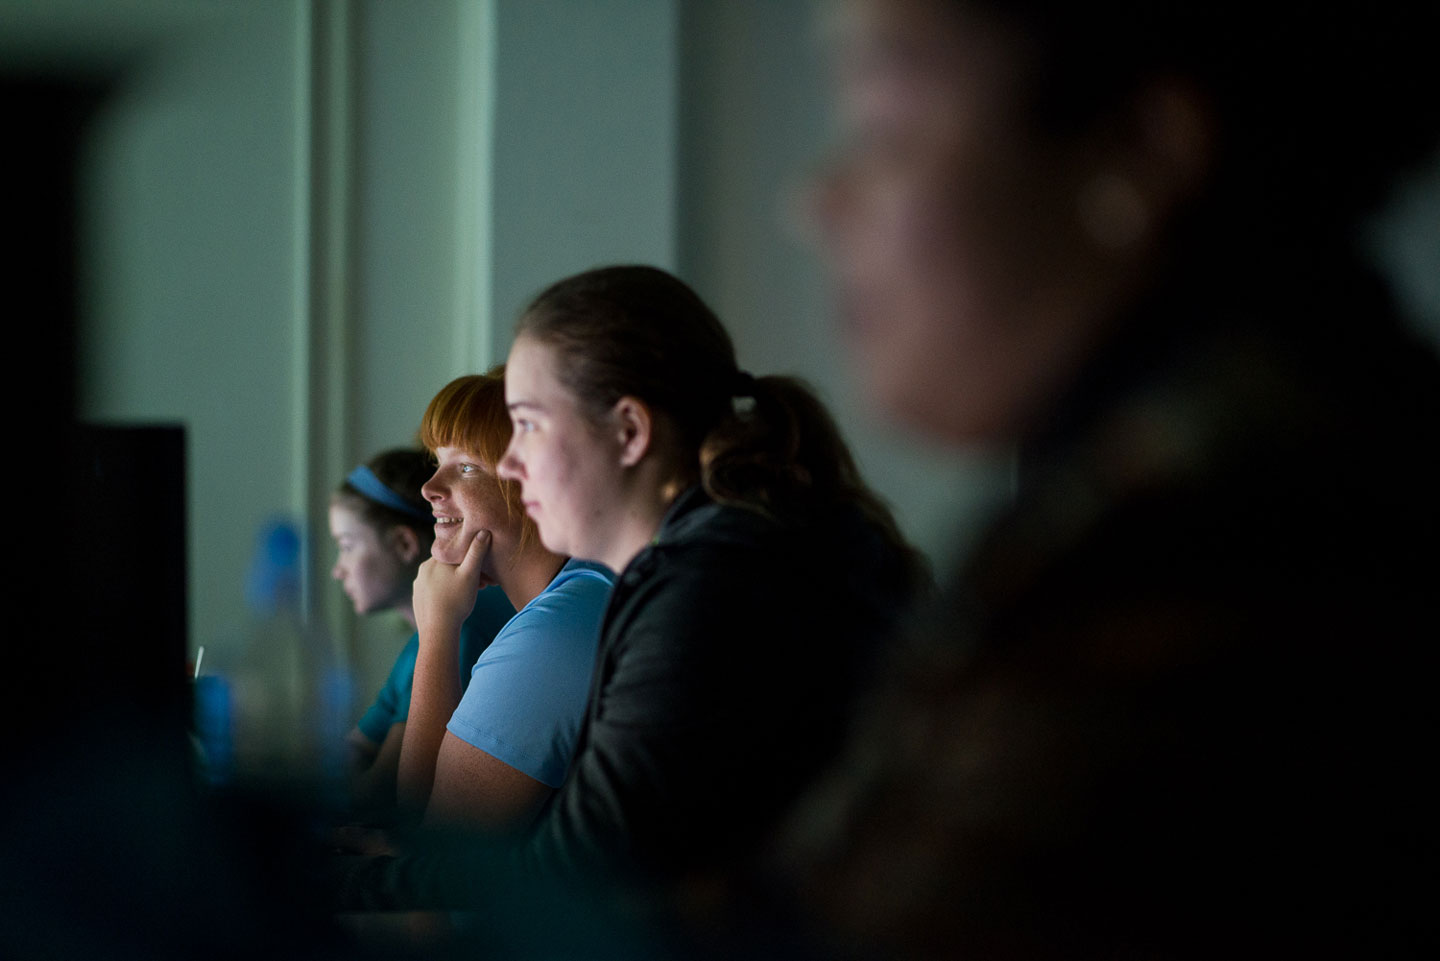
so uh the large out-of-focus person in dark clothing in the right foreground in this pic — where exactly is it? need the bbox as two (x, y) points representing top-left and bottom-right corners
(780, 0), (1440, 958)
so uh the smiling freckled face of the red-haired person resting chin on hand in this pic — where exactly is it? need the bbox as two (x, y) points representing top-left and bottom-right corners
(420, 447), (523, 584)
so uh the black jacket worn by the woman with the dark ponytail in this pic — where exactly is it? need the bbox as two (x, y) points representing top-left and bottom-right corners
(341, 487), (910, 933)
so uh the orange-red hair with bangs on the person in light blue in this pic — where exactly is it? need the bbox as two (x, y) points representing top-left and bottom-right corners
(420, 365), (539, 547)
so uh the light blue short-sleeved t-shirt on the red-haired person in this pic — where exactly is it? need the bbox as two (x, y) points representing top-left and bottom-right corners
(446, 560), (615, 788)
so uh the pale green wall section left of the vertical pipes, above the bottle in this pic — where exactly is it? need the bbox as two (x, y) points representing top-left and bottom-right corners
(78, 3), (316, 677)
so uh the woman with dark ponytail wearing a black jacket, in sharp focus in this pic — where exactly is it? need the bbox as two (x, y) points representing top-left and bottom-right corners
(500, 267), (917, 899)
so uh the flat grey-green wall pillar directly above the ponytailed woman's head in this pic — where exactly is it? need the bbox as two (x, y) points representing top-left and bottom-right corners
(491, 0), (681, 359)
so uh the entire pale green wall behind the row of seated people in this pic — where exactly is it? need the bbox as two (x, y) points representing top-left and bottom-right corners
(0, 0), (1440, 705)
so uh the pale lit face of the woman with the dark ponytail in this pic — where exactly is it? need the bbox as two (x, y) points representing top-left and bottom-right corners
(500, 336), (621, 562)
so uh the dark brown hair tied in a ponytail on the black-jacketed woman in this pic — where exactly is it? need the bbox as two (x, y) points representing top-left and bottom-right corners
(517, 265), (919, 587)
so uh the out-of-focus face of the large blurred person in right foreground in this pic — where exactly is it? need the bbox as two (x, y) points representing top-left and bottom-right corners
(814, 0), (1094, 442)
